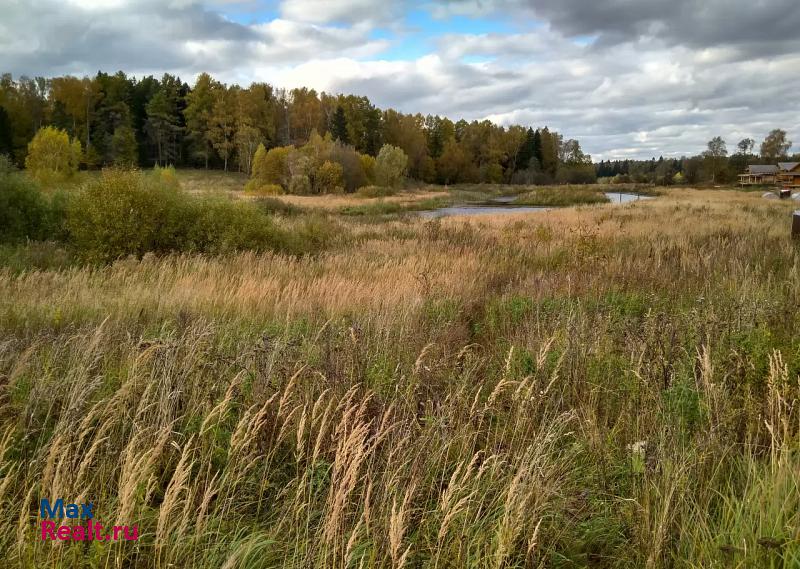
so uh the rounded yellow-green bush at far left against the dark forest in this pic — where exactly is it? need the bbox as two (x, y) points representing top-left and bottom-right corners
(25, 126), (81, 183)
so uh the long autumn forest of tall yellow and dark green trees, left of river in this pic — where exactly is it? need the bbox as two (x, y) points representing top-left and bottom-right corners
(0, 71), (595, 186)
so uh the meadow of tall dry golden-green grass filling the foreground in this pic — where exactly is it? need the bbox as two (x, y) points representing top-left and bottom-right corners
(0, 174), (800, 569)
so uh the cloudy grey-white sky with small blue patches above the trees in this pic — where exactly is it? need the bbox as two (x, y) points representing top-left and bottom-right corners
(0, 0), (800, 161)
